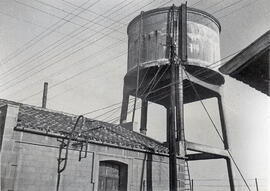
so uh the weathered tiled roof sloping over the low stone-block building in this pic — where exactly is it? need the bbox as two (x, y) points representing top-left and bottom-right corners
(0, 99), (168, 153)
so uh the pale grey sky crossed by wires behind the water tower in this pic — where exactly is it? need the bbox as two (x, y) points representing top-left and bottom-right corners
(0, 0), (270, 191)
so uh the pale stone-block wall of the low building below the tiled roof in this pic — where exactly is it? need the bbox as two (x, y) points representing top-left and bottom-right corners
(0, 103), (184, 191)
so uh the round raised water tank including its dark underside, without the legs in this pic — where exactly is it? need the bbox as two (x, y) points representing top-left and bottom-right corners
(124, 7), (224, 107)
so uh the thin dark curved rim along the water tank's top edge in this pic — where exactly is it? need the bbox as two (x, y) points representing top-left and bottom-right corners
(127, 6), (221, 32)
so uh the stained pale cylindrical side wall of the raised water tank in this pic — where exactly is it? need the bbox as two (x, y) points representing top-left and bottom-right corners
(127, 7), (224, 84)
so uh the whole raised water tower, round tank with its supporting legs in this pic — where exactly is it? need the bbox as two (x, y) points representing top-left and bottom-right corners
(120, 4), (234, 190)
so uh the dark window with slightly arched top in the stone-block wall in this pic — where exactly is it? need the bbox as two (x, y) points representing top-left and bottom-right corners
(98, 161), (127, 191)
